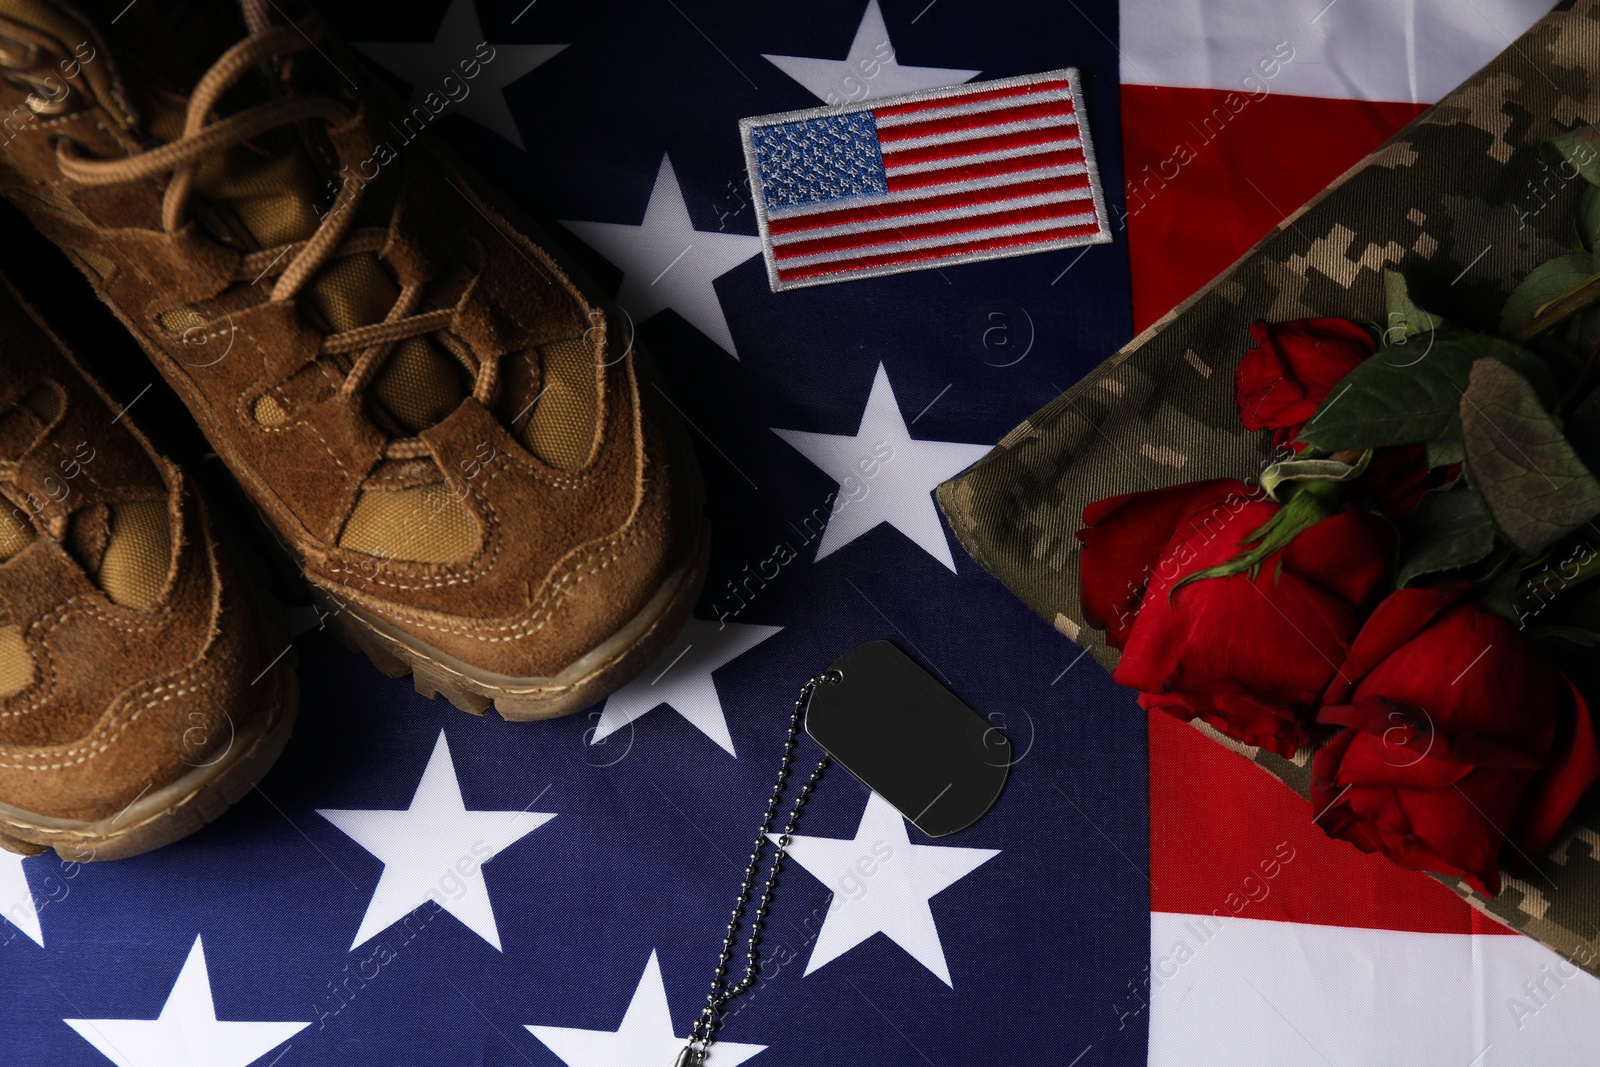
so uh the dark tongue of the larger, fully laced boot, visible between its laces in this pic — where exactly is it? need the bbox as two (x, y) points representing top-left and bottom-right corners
(68, 0), (469, 435)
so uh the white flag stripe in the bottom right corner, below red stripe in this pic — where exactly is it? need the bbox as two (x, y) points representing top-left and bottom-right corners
(1152, 912), (1600, 1067)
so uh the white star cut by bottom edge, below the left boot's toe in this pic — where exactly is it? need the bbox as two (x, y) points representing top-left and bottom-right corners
(62, 937), (310, 1067)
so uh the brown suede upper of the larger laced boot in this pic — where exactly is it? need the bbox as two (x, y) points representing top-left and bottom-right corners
(0, 6), (699, 678)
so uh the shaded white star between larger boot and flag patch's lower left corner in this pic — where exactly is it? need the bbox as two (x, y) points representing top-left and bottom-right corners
(562, 155), (762, 358)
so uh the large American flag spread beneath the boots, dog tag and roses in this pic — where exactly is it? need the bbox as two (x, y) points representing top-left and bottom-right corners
(0, 0), (1600, 1067)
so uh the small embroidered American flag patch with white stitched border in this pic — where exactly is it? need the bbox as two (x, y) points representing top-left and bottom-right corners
(739, 69), (1110, 293)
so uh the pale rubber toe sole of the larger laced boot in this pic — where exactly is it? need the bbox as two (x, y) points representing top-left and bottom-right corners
(312, 522), (710, 721)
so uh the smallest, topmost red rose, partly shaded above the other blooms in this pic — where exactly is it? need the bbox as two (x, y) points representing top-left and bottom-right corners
(1234, 318), (1378, 448)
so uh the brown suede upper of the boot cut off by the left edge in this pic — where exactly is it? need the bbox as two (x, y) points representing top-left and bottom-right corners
(0, 278), (285, 833)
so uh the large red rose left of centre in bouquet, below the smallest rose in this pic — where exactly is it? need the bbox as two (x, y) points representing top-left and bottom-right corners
(1078, 480), (1394, 755)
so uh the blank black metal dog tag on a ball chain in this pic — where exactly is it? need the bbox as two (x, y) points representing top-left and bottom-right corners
(805, 641), (1011, 837)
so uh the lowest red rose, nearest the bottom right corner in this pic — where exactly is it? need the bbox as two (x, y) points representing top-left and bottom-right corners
(1312, 585), (1600, 894)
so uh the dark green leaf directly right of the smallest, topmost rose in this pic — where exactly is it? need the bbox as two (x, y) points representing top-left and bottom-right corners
(1299, 330), (1539, 453)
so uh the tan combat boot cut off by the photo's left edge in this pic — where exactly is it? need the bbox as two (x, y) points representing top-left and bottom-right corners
(0, 278), (296, 861)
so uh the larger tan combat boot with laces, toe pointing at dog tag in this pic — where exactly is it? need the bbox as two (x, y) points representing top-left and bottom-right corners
(0, 0), (706, 718)
